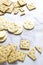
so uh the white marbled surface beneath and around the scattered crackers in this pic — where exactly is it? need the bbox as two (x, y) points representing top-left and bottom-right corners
(0, 0), (43, 65)
